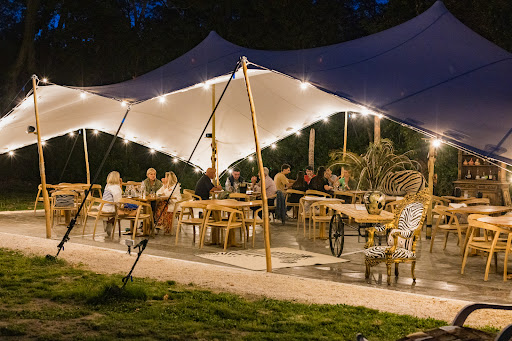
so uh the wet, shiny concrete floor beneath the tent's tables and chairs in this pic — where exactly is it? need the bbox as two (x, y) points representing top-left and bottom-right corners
(0, 211), (512, 304)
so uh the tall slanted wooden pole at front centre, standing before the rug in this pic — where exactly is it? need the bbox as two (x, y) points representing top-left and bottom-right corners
(242, 57), (272, 272)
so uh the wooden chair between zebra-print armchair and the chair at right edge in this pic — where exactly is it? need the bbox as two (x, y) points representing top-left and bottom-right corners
(430, 206), (468, 255)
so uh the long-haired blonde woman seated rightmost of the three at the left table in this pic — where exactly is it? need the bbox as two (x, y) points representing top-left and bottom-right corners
(155, 171), (181, 233)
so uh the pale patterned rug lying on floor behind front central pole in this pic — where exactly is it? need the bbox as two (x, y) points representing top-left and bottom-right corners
(198, 247), (348, 270)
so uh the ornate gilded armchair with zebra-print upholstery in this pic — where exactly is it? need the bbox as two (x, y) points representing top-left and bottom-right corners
(364, 189), (431, 285)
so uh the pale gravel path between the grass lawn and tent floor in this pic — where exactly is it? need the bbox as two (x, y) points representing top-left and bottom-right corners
(0, 233), (512, 328)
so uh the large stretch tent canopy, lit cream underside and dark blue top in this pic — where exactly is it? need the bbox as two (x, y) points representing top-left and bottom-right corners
(0, 1), (512, 170)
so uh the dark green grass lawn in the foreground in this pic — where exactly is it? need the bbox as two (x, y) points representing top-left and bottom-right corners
(0, 249), (476, 340)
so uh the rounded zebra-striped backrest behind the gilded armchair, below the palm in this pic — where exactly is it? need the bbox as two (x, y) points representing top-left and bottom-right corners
(379, 170), (427, 196)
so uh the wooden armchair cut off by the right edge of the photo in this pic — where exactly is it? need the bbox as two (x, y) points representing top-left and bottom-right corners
(460, 214), (512, 281)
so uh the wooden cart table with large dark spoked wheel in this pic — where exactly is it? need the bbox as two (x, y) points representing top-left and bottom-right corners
(326, 204), (395, 257)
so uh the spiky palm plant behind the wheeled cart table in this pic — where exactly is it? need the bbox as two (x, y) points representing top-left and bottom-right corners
(329, 139), (421, 190)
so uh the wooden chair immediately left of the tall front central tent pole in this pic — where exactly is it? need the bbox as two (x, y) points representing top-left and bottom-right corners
(199, 205), (245, 251)
